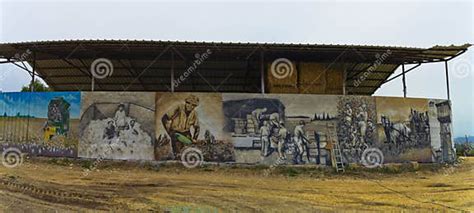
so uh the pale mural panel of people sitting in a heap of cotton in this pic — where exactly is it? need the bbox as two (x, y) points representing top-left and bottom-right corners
(79, 92), (155, 160)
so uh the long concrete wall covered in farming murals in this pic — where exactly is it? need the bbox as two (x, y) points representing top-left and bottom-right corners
(0, 92), (454, 165)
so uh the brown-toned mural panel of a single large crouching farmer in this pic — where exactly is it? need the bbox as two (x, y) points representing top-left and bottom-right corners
(155, 93), (234, 162)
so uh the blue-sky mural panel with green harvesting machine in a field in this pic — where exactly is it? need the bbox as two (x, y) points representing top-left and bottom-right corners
(0, 92), (81, 157)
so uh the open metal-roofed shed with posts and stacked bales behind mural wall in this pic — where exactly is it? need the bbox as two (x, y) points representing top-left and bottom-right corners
(0, 40), (470, 96)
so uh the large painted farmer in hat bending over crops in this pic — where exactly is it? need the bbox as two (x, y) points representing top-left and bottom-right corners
(161, 95), (199, 157)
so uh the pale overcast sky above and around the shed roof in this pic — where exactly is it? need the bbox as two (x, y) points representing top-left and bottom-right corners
(0, 0), (474, 136)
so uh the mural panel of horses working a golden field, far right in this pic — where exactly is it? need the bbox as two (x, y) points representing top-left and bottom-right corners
(375, 97), (432, 162)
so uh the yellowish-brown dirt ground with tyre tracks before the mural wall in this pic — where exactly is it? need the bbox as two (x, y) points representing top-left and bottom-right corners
(0, 158), (474, 212)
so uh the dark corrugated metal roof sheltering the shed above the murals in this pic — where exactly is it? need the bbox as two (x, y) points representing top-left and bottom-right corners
(0, 40), (471, 95)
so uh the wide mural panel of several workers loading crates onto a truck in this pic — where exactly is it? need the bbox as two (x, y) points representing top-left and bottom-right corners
(223, 94), (337, 164)
